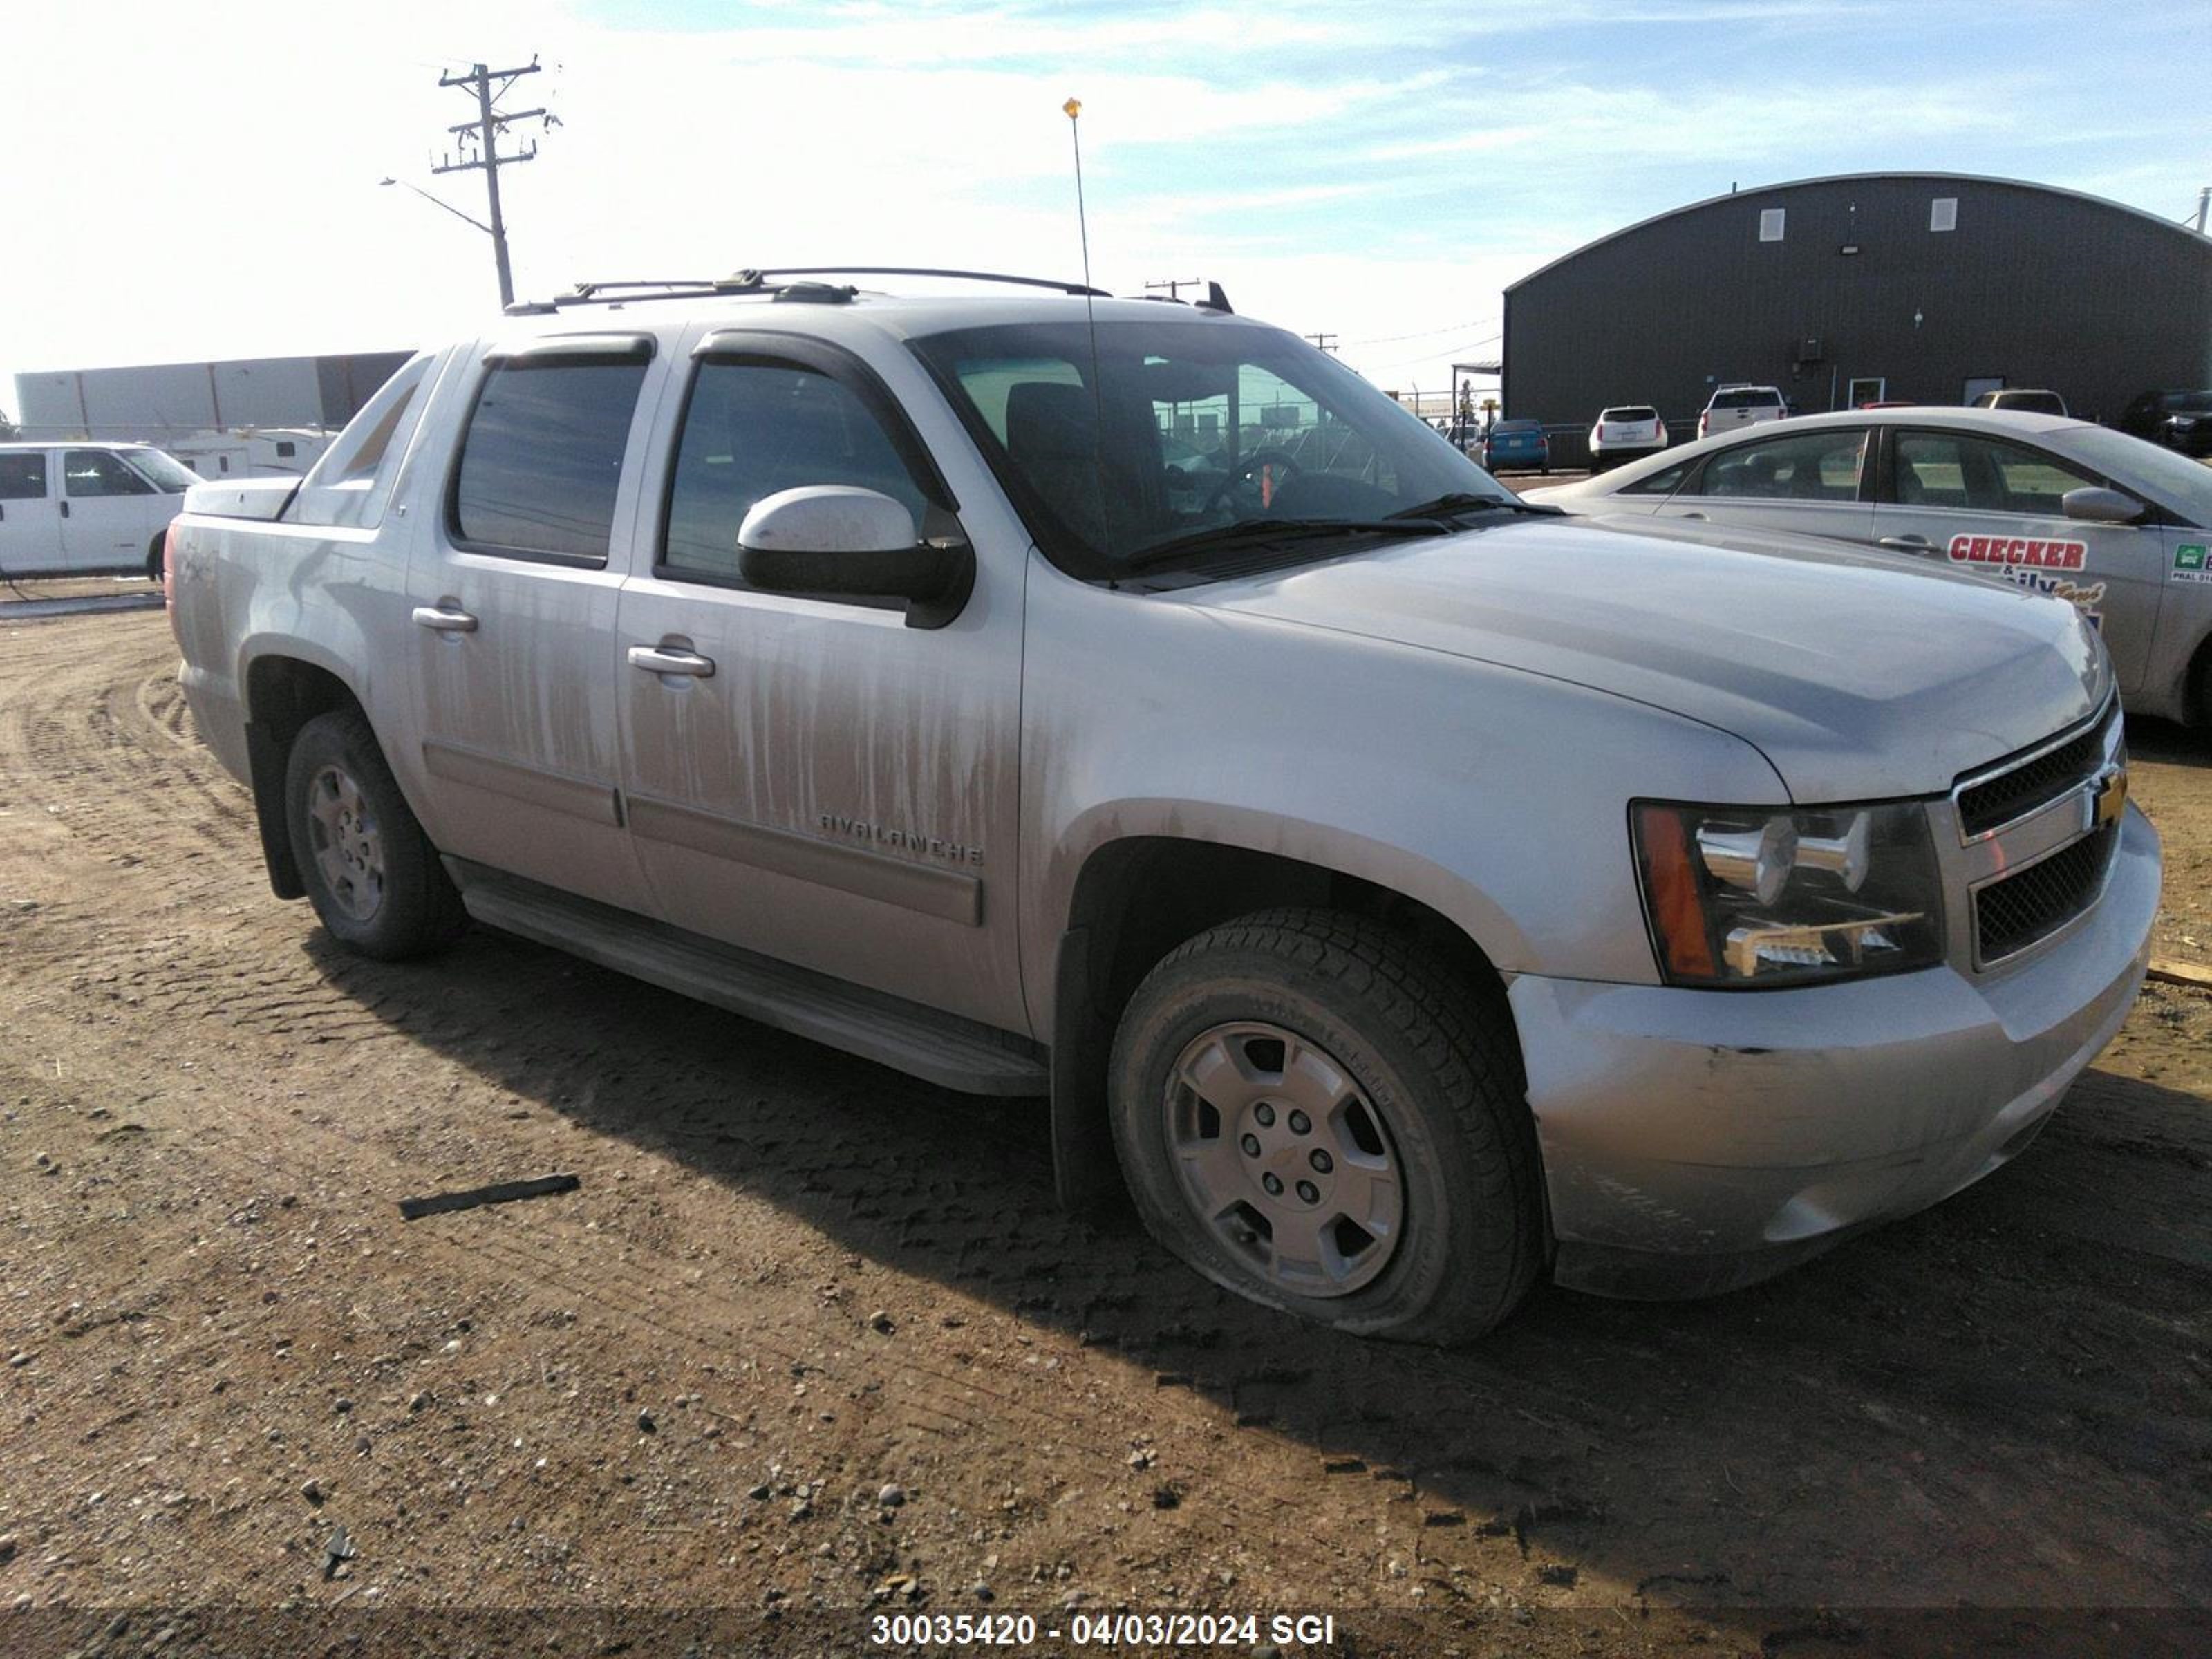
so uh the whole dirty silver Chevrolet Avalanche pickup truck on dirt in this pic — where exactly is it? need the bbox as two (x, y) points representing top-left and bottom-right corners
(168, 272), (2159, 1340)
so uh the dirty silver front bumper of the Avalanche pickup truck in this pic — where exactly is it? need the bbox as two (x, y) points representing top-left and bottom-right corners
(1511, 805), (2159, 1296)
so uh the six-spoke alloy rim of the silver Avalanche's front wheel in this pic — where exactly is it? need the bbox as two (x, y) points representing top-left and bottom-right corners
(1163, 1020), (1405, 1296)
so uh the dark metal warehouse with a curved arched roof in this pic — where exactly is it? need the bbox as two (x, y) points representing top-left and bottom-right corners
(1504, 173), (2212, 462)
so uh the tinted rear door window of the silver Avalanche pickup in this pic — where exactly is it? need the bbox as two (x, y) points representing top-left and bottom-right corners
(453, 358), (646, 564)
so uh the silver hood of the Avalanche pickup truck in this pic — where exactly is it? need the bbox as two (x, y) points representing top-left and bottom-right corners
(1177, 518), (2110, 800)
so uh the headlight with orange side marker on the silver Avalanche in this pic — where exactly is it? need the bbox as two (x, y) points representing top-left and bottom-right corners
(1628, 800), (1942, 988)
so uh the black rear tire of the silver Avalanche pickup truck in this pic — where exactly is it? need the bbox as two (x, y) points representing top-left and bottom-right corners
(283, 708), (467, 962)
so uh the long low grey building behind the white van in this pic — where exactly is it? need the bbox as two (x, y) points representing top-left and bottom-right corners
(15, 352), (411, 442)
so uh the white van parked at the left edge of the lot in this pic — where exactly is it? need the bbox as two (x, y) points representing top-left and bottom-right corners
(0, 442), (201, 577)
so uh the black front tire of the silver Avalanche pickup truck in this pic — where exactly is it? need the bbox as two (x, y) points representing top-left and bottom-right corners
(1108, 909), (1546, 1342)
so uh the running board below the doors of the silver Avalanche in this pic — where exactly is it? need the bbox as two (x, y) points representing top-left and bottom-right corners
(444, 859), (1051, 1095)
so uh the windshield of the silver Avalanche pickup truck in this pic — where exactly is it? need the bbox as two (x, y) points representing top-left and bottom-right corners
(914, 308), (1515, 579)
